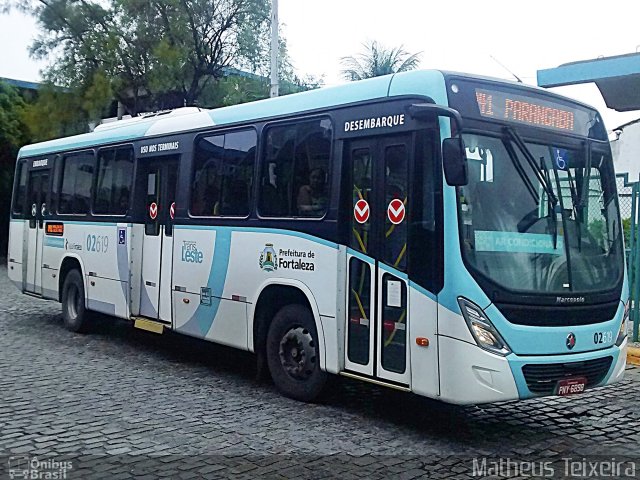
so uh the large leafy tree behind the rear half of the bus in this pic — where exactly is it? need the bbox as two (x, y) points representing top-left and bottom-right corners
(3, 0), (270, 115)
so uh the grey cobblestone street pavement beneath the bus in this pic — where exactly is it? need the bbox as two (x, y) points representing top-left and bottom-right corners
(0, 267), (640, 479)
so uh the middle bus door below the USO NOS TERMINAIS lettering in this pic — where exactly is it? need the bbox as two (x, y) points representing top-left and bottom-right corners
(140, 155), (179, 323)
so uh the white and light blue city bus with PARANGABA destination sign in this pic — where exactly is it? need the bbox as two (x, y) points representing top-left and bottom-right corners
(8, 71), (629, 404)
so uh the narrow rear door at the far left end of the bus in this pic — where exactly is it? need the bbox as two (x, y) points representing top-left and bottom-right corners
(23, 162), (50, 295)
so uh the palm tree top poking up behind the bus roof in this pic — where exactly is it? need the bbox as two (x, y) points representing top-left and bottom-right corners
(341, 41), (422, 81)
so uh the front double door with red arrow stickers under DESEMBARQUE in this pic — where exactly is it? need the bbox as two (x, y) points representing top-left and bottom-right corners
(345, 135), (412, 387)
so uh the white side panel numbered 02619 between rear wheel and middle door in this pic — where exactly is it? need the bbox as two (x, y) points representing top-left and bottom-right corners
(63, 222), (130, 318)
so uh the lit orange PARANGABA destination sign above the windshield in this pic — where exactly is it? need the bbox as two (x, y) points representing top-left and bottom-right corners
(476, 88), (591, 133)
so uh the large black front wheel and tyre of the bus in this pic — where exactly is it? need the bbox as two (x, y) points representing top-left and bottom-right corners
(266, 305), (327, 402)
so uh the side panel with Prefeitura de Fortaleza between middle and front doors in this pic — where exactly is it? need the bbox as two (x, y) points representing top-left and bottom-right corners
(173, 226), (338, 371)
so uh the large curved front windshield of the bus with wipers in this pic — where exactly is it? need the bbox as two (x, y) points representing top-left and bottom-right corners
(458, 130), (623, 294)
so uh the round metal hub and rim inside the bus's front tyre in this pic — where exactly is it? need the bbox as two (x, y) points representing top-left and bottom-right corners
(279, 327), (316, 380)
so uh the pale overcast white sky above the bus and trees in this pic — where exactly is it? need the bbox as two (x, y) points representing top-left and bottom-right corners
(0, 0), (640, 130)
